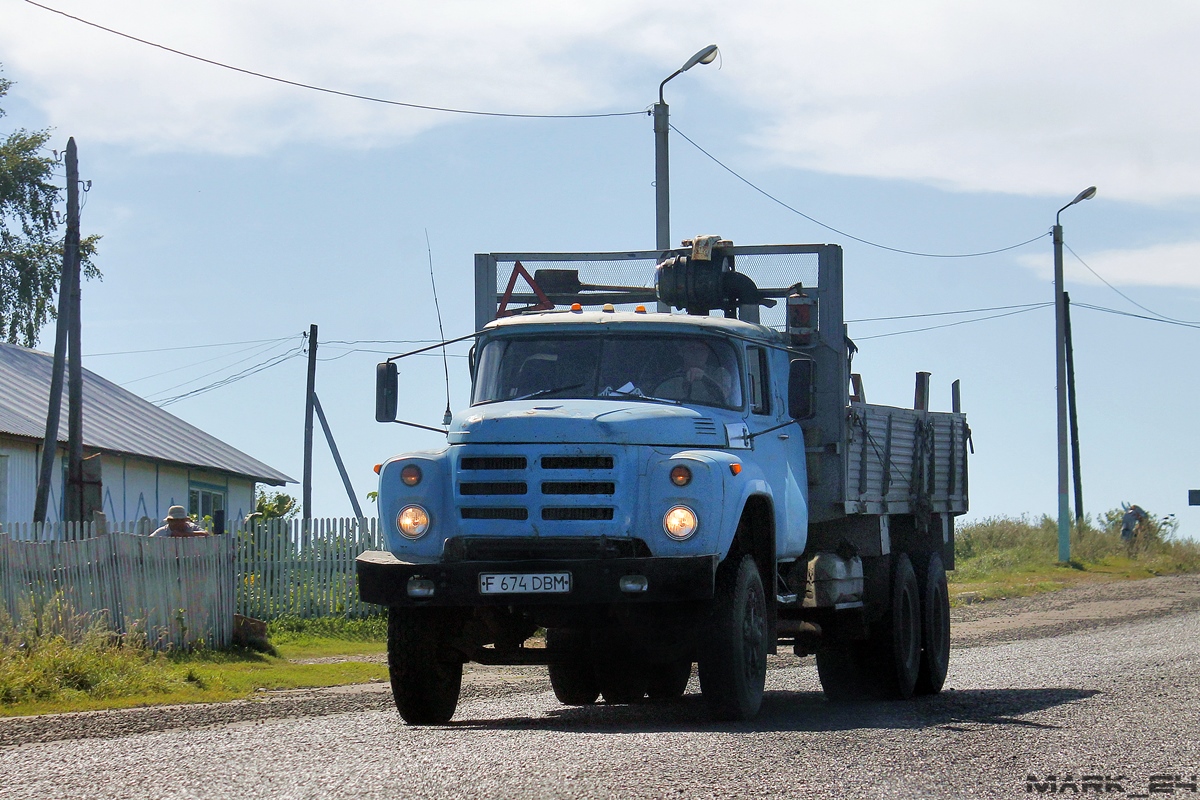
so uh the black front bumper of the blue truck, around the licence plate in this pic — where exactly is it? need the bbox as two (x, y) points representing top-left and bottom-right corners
(356, 551), (718, 607)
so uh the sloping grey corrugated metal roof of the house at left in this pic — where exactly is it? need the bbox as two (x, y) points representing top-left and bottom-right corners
(0, 343), (295, 486)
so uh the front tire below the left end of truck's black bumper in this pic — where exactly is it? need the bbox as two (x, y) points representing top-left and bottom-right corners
(388, 608), (462, 724)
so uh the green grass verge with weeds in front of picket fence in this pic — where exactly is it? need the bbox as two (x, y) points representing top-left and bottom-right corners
(0, 614), (388, 716)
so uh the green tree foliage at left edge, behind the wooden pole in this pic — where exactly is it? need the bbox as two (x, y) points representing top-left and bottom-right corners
(0, 66), (100, 347)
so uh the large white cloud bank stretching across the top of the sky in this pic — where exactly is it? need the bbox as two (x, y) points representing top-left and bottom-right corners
(0, 0), (1200, 203)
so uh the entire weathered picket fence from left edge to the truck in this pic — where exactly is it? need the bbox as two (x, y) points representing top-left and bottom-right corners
(0, 518), (383, 646)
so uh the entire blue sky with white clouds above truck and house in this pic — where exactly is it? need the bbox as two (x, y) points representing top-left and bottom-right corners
(0, 0), (1200, 536)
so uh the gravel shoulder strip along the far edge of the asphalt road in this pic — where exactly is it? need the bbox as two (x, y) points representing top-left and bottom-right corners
(0, 575), (1200, 748)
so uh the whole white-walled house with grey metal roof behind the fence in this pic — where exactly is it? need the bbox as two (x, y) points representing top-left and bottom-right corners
(0, 343), (295, 523)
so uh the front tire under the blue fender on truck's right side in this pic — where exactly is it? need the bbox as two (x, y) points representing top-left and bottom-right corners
(700, 555), (768, 720)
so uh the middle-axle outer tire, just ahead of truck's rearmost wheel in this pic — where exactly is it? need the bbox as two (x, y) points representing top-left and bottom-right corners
(874, 553), (921, 700)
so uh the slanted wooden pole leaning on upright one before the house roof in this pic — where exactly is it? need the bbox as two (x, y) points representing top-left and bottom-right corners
(34, 137), (79, 522)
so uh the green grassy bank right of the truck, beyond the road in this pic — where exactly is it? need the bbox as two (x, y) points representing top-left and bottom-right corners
(950, 510), (1200, 603)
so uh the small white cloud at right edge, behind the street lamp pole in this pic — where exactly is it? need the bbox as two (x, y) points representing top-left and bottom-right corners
(1019, 242), (1200, 289)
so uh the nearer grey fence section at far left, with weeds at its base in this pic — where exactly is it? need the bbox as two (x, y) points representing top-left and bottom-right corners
(0, 533), (235, 648)
